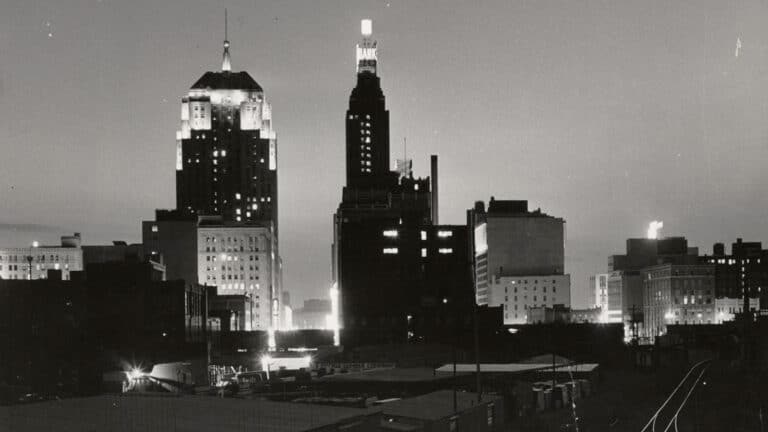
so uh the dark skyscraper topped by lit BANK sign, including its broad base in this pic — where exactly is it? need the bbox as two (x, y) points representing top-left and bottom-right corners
(332, 20), (472, 346)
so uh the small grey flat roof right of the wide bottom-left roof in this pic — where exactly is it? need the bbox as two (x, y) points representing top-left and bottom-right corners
(377, 390), (501, 420)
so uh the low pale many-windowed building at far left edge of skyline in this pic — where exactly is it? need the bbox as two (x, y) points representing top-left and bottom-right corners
(0, 233), (83, 280)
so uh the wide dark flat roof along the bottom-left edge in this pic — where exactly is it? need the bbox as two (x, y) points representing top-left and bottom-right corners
(0, 394), (375, 432)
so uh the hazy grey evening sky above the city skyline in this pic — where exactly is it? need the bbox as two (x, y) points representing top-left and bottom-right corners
(0, 0), (768, 306)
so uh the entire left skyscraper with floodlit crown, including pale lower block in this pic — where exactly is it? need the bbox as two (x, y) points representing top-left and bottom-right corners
(143, 14), (282, 330)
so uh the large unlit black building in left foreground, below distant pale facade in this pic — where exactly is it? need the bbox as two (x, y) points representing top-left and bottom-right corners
(0, 262), (207, 402)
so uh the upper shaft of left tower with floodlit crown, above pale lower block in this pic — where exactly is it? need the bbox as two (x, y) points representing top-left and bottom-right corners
(176, 27), (277, 230)
